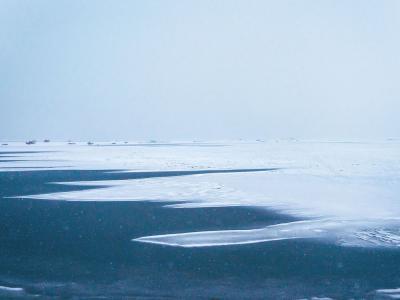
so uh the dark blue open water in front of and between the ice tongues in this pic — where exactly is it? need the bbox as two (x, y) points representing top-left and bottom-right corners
(0, 154), (400, 299)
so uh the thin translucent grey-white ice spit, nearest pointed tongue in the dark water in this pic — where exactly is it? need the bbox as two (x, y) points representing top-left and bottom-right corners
(134, 219), (400, 248)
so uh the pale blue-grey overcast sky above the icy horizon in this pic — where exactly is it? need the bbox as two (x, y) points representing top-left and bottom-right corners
(0, 0), (400, 140)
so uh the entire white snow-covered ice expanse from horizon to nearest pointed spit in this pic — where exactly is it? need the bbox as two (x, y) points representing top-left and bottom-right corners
(0, 140), (400, 247)
